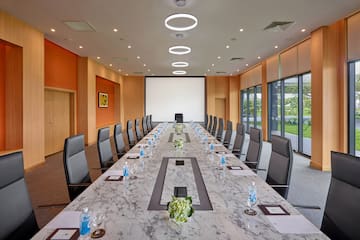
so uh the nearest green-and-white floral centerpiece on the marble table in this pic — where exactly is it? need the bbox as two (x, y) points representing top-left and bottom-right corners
(168, 196), (194, 223)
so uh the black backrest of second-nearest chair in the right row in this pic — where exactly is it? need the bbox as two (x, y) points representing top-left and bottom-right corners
(266, 135), (293, 199)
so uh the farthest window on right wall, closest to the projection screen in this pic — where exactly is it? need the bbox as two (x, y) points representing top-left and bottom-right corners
(240, 86), (262, 132)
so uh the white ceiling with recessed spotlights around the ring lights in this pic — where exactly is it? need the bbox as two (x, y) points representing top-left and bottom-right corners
(0, 0), (360, 76)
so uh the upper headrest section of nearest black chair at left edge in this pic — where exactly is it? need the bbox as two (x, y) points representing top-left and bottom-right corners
(0, 152), (24, 188)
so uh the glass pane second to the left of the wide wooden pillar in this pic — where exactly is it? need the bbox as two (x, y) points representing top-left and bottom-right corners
(284, 77), (299, 151)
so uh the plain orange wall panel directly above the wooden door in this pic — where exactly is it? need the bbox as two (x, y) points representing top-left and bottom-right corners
(44, 39), (77, 91)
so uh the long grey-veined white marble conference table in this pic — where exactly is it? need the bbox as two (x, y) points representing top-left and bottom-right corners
(33, 123), (328, 240)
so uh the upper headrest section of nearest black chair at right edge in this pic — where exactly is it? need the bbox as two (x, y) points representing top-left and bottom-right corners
(331, 151), (360, 188)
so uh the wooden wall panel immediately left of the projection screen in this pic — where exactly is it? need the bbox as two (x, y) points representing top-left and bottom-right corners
(123, 76), (145, 124)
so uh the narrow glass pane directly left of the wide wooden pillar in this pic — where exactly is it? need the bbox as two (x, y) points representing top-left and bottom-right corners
(302, 73), (311, 156)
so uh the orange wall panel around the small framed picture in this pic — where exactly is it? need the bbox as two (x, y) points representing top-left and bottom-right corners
(96, 76), (117, 128)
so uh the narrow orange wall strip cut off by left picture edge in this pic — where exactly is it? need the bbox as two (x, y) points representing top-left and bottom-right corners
(0, 43), (5, 151)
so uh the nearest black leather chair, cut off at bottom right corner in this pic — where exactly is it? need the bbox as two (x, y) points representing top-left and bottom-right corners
(321, 152), (360, 240)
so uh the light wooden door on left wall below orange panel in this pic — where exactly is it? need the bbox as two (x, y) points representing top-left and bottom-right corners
(45, 89), (72, 156)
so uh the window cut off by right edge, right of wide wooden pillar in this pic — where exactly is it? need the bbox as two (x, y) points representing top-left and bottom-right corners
(348, 60), (360, 156)
